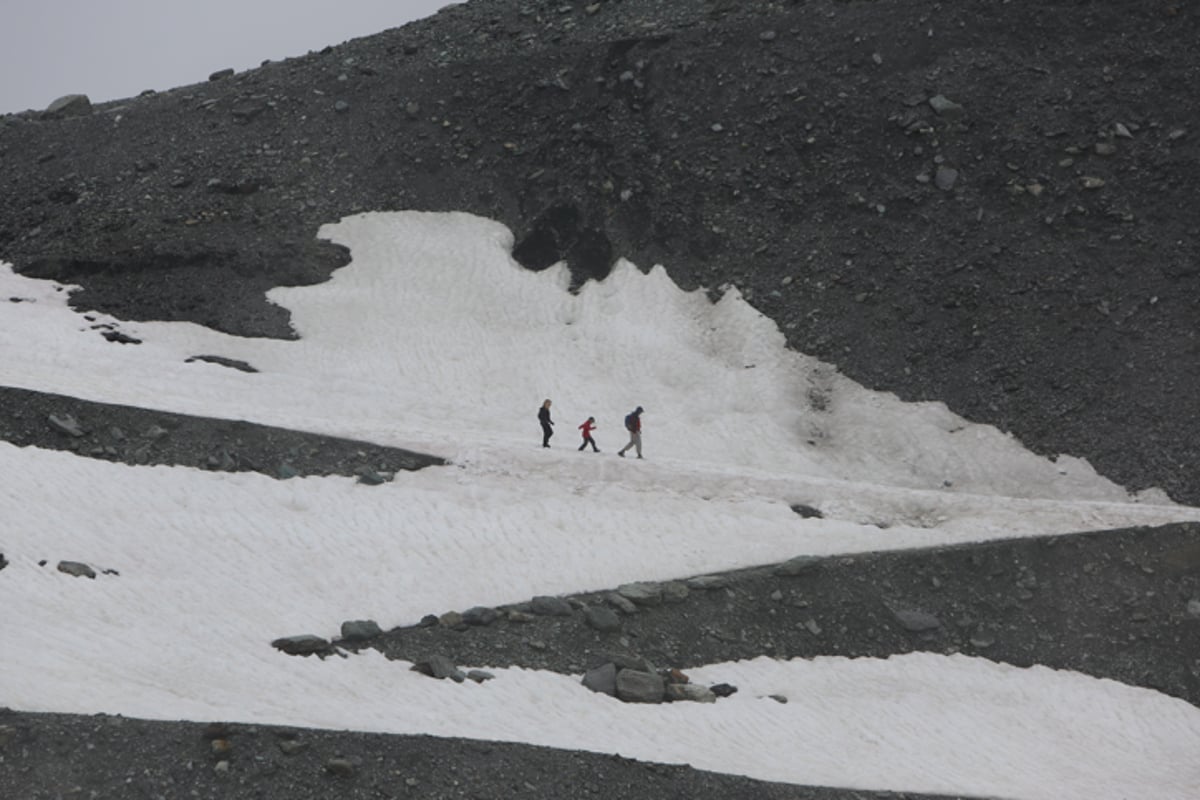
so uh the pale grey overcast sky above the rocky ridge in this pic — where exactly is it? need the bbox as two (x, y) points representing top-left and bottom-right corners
(0, 0), (454, 114)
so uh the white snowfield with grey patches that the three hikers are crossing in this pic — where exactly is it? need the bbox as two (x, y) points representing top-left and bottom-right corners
(0, 212), (1200, 800)
